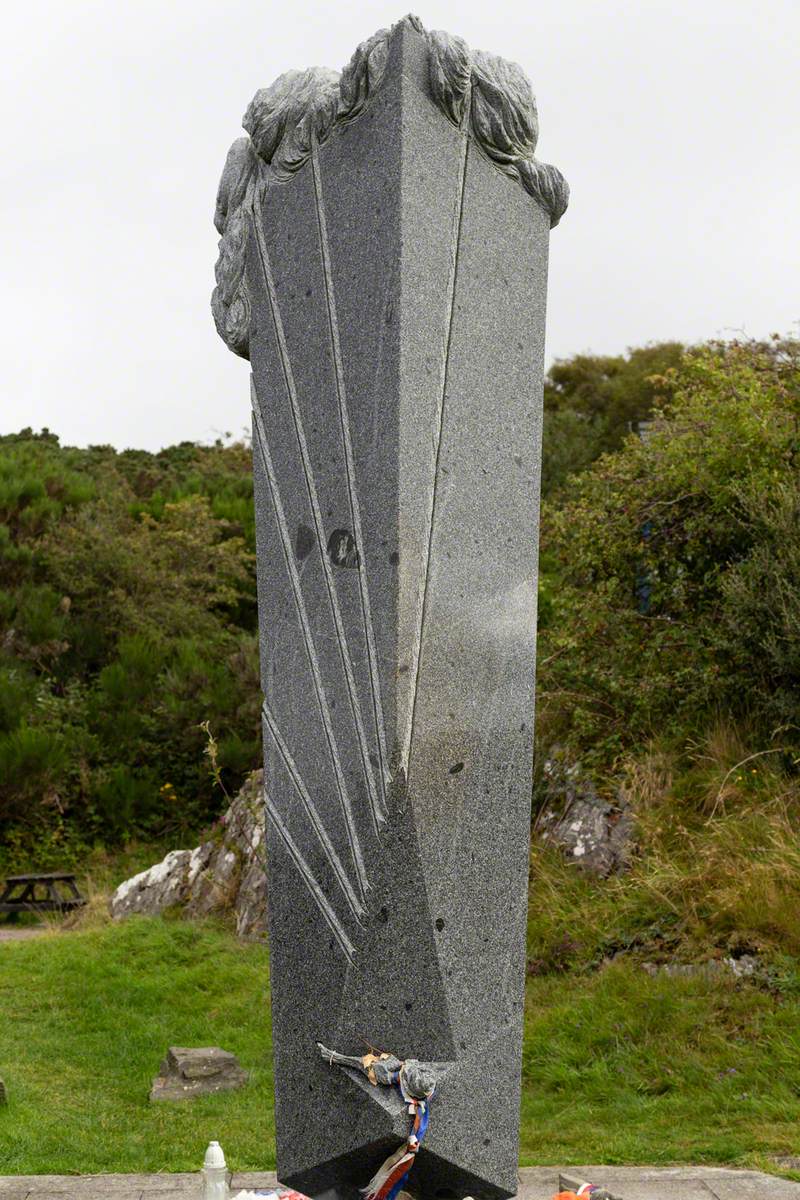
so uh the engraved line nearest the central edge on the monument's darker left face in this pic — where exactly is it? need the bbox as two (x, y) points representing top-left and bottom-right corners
(311, 138), (391, 821)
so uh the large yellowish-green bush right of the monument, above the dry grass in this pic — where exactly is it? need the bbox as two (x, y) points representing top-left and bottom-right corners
(540, 338), (800, 763)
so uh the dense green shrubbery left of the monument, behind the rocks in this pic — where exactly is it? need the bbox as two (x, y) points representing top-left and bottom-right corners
(0, 431), (259, 858)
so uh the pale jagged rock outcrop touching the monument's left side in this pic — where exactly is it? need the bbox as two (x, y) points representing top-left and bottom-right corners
(110, 770), (266, 937)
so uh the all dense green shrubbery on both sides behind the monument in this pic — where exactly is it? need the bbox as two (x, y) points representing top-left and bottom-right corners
(0, 340), (800, 858)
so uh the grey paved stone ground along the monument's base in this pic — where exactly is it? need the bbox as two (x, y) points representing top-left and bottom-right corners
(0, 1166), (800, 1200)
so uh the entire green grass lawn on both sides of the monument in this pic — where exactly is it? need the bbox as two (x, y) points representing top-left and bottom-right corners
(0, 918), (800, 1175)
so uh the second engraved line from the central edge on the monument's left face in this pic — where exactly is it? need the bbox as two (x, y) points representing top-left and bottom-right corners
(254, 218), (380, 830)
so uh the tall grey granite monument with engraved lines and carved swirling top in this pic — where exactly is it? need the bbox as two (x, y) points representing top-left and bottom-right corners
(212, 17), (567, 1200)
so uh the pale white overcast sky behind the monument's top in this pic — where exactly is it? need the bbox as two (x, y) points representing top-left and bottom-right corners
(0, 0), (800, 449)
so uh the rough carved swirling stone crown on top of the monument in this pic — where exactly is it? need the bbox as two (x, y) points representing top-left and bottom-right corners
(211, 17), (570, 358)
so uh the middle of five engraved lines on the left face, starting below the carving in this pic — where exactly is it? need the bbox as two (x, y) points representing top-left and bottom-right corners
(252, 385), (368, 899)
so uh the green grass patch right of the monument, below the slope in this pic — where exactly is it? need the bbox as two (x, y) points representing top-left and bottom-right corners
(522, 961), (800, 1166)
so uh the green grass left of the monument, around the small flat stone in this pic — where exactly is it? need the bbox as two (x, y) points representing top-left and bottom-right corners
(0, 918), (275, 1175)
